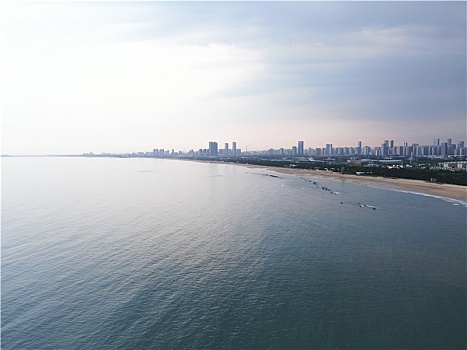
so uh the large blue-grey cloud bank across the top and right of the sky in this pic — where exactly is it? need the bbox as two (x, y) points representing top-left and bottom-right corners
(6, 2), (466, 124)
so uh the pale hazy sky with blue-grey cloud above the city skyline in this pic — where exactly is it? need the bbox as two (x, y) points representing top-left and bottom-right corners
(0, 1), (467, 154)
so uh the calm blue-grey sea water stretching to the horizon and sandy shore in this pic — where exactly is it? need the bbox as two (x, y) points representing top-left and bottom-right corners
(1, 158), (467, 349)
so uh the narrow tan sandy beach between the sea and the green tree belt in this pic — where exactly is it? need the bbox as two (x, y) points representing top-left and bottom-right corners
(216, 162), (467, 202)
